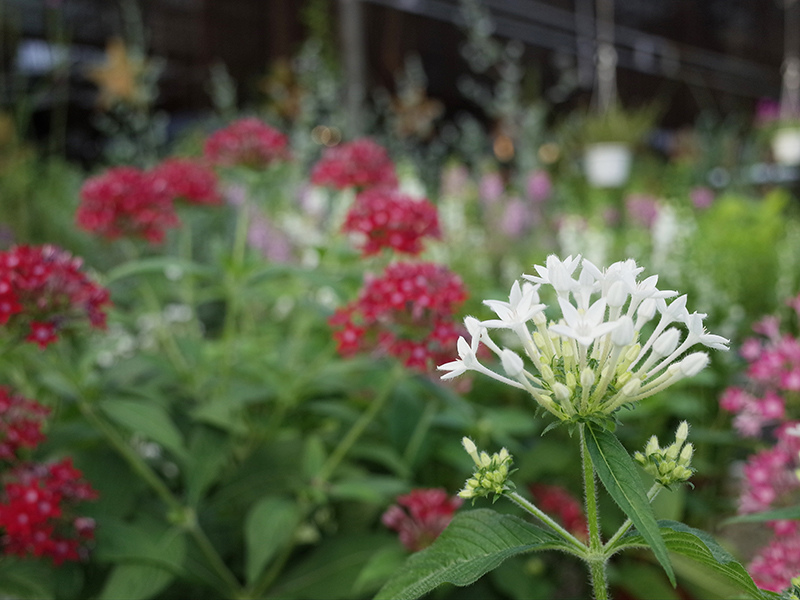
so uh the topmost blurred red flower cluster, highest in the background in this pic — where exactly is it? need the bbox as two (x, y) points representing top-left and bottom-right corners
(203, 117), (289, 167)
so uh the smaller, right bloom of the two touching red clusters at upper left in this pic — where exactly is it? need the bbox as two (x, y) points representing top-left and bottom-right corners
(150, 158), (222, 206)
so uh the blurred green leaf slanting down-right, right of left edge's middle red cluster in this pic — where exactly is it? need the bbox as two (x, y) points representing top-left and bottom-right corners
(99, 398), (187, 460)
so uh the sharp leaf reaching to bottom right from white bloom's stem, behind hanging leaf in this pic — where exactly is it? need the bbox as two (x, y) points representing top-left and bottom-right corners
(622, 520), (764, 598)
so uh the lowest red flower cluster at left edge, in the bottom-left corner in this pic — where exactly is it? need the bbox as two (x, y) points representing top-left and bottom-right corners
(0, 458), (97, 565)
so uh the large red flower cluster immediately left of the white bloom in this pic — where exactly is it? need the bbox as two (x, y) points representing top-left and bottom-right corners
(330, 263), (467, 370)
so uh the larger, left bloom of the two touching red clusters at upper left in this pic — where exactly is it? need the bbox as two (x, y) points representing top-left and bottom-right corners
(76, 167), (179, 244)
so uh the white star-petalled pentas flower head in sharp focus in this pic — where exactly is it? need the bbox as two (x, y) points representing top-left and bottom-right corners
(439, 256), (728, 422)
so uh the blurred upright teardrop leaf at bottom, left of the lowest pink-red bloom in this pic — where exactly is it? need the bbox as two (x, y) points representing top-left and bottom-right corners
(245, 496), (301, 584)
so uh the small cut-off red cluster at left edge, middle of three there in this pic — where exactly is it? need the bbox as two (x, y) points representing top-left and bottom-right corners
(0, 386), (50, 461)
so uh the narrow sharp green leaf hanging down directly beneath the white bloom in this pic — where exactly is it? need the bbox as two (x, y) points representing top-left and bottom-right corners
(585, 425), (675, 586)
